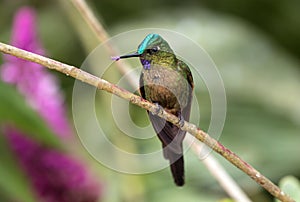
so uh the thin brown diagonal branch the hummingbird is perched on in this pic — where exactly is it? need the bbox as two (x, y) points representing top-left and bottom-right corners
(0, 43), (294, 202)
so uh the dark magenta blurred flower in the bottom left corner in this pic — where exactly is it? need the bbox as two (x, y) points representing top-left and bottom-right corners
(6, 128), (99, 202)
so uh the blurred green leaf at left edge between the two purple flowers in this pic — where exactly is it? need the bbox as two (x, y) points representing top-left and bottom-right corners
(0, 82), (60, 147)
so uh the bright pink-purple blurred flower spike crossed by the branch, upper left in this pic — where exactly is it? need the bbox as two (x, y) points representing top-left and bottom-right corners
(1, 7), (71, 137)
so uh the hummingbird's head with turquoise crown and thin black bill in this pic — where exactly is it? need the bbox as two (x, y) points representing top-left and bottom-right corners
(113, 34), (176, 69)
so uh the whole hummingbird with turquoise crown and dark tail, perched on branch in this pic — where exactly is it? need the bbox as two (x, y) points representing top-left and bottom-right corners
(113, 33), (194, 186)
